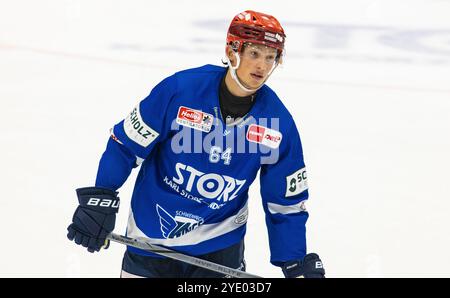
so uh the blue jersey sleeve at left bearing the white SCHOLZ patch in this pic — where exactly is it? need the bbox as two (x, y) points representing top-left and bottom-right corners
(95, 76), (176, 190)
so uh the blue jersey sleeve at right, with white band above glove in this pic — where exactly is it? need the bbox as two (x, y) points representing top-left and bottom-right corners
(260, 121), (308, 266)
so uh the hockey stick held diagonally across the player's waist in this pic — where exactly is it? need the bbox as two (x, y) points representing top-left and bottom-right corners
(106, 233), (262, 278)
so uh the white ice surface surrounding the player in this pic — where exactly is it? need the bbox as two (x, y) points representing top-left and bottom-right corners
(0, 0), (450, 277)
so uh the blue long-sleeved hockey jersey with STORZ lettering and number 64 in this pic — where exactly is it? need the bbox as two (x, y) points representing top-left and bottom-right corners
(96, 65), (308, 266)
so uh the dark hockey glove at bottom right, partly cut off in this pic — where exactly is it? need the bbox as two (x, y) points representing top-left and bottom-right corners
(282, 253), (325, 278)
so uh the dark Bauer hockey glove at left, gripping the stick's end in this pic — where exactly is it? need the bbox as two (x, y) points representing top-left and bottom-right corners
(67, 187), (120, 252)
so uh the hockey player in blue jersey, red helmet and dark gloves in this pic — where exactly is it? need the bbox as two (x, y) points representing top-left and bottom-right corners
(68, 11), (325, 277)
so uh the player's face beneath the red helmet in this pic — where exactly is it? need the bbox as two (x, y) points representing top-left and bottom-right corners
(237, 44), (277, 89)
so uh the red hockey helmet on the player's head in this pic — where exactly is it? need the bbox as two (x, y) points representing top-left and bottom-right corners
(227, 10), (286, 55)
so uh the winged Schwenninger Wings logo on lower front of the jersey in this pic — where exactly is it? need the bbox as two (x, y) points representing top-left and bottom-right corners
(156, 204), (205, 239)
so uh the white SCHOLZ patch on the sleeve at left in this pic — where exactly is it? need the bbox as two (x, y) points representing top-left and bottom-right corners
(123, 104), (159, 147)
